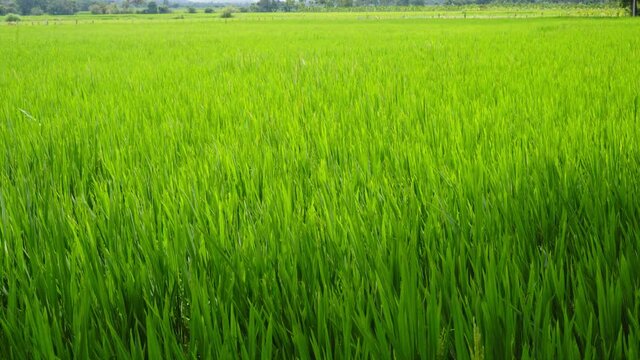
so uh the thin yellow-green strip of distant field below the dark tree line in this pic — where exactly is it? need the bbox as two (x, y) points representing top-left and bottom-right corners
(3, 4), (629, 25)
